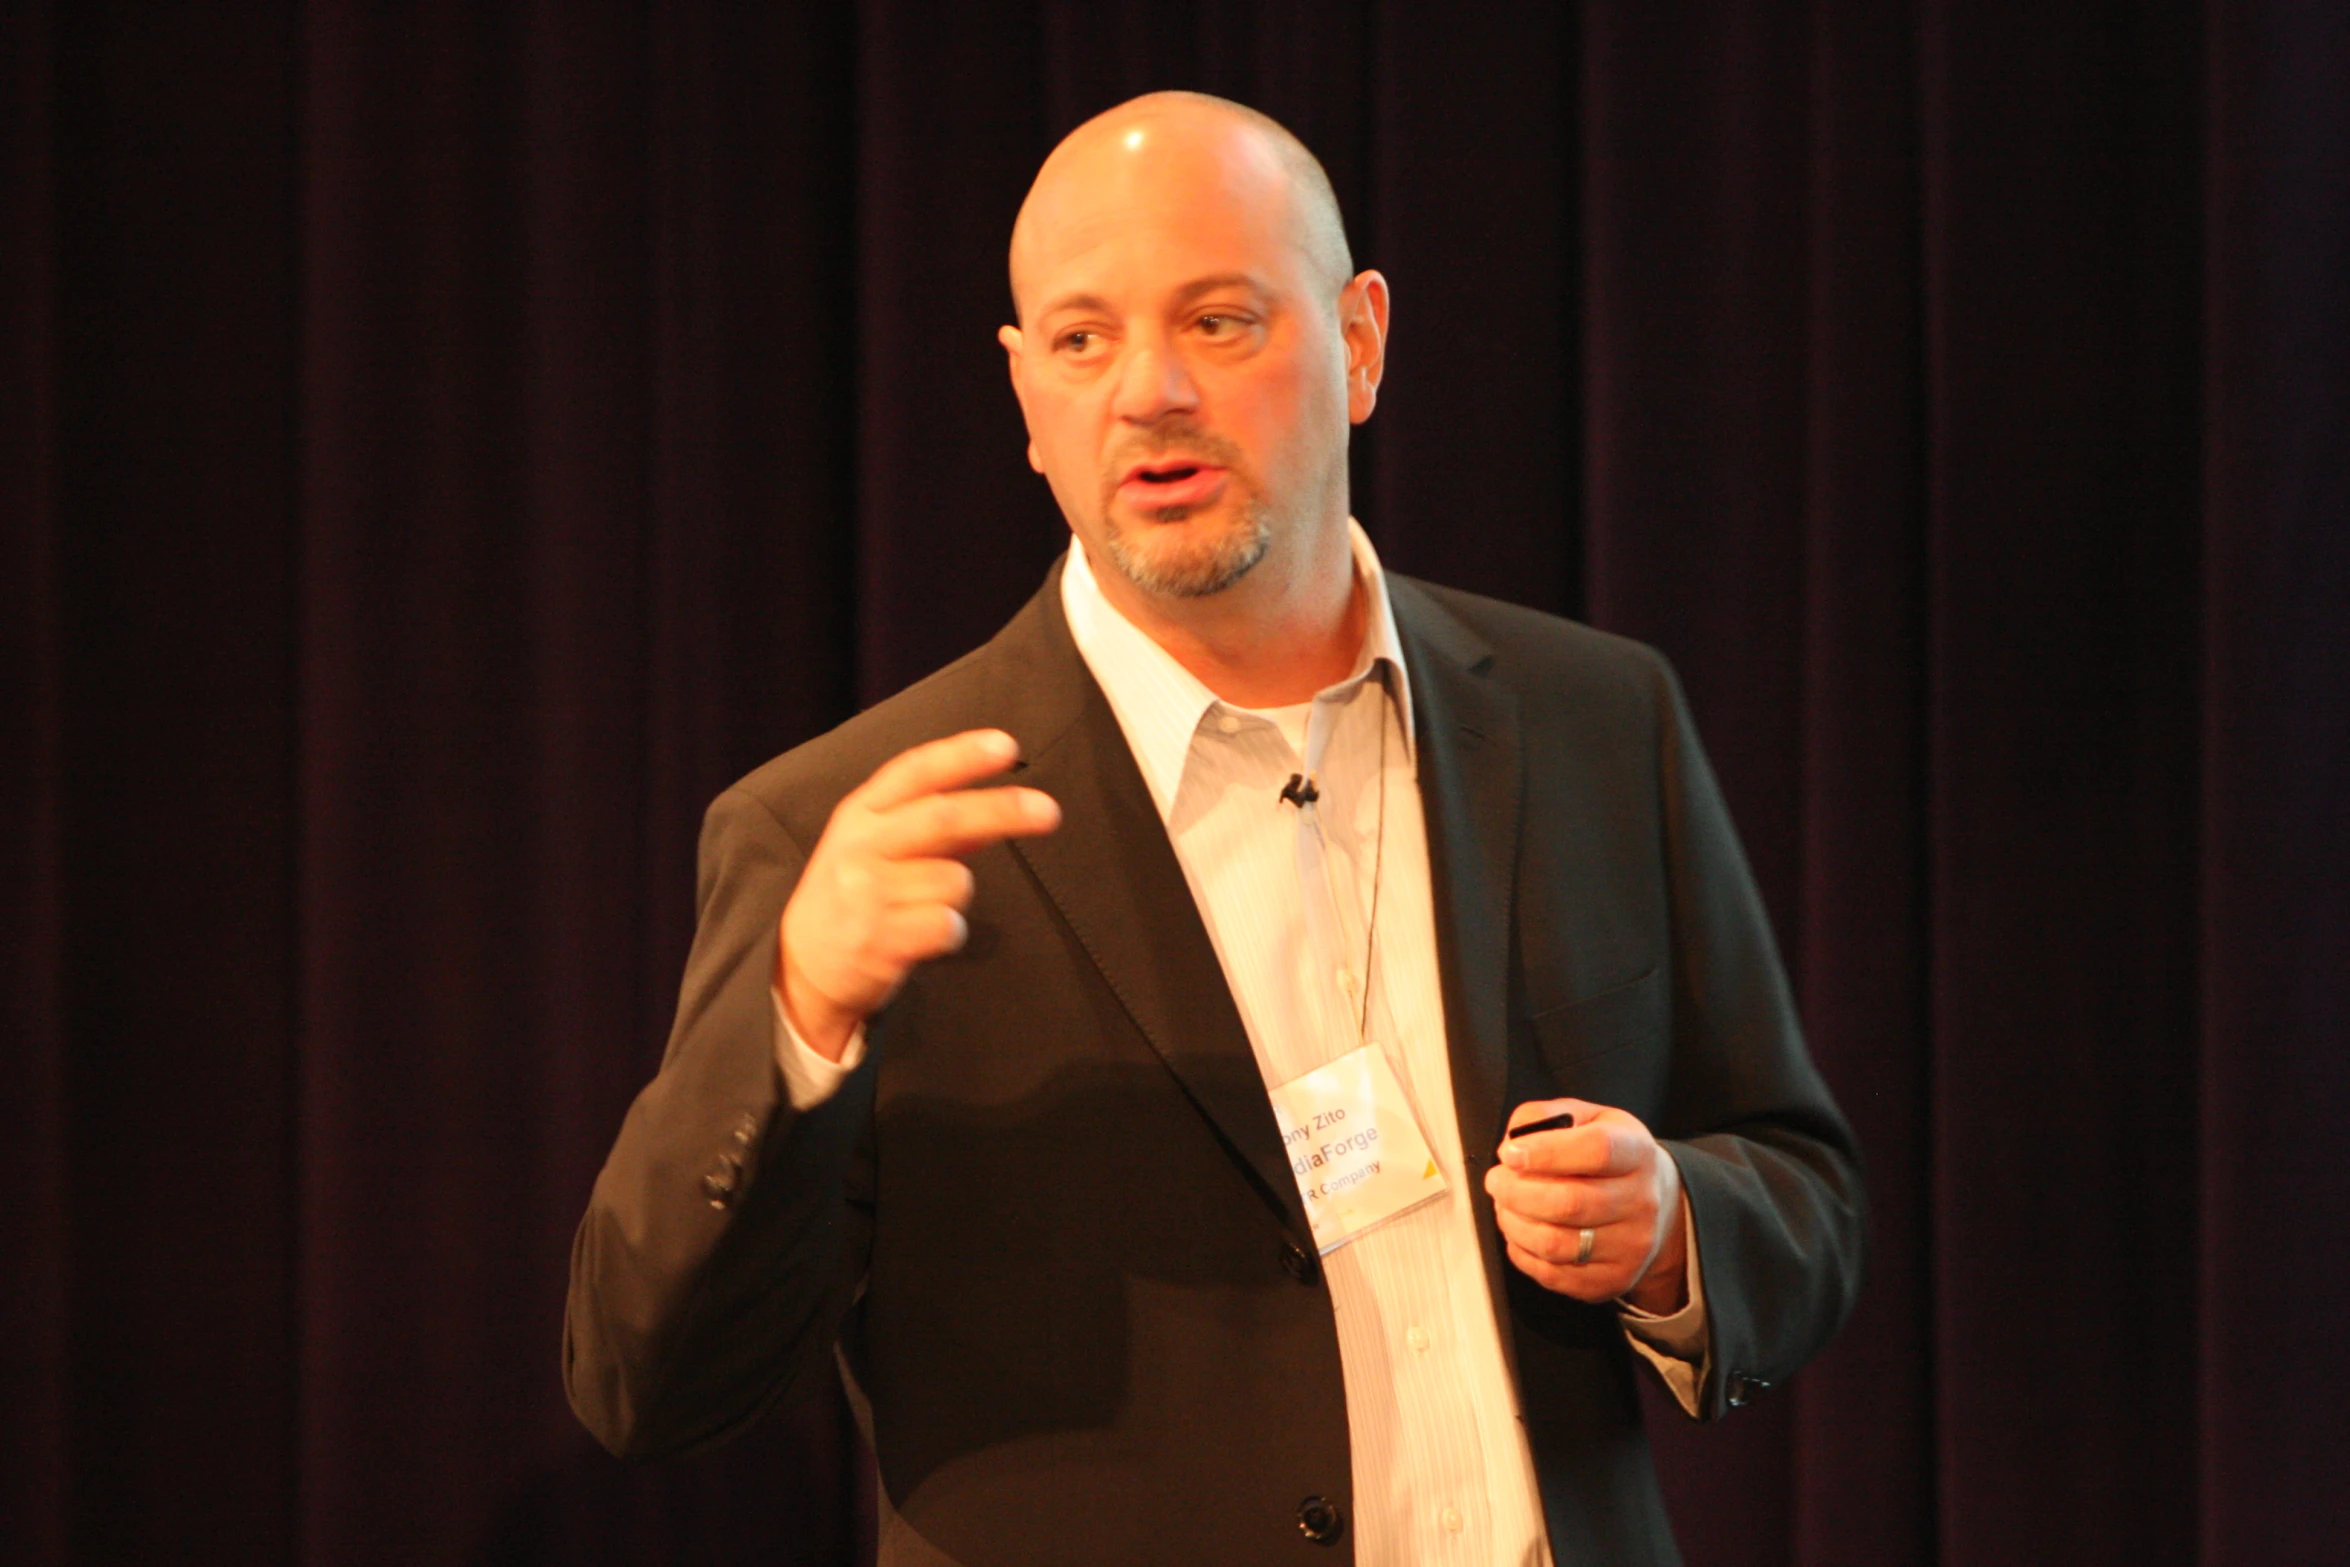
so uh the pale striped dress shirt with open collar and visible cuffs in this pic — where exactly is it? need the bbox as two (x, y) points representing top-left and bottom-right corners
(776, 524), (1706, 1567)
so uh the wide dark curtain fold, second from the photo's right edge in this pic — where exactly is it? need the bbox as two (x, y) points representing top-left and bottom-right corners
(1920, 5), (2200, 1562)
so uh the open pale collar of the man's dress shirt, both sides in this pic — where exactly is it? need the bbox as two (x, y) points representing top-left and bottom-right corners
(1060, 517), (1412, 820)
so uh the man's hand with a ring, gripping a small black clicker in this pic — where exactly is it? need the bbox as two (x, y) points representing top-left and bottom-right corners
(1485, 1099), (1690, 1316)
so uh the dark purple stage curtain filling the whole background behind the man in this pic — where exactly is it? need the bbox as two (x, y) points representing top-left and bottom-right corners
(0, 0), (2350, 1567)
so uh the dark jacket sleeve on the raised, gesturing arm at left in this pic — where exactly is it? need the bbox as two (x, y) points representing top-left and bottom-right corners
(564, 789), (874, 1457)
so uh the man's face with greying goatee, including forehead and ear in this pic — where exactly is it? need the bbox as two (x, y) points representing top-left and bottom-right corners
(1001, 120), (1384, 599)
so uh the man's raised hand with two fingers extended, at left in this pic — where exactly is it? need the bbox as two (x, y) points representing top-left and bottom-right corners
(776, 728), (1060, 1062)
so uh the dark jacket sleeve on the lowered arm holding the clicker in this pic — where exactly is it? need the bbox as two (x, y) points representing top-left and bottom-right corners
(1657, 658), (1864, 1419)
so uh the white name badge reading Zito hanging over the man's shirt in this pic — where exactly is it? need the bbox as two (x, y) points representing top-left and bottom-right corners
(1271, 1045), (1445, 1257)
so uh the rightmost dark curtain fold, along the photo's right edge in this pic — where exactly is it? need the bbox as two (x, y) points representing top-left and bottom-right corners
(2193, 2), (2350, 1562)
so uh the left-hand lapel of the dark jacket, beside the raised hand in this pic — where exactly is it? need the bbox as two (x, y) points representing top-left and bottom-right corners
(999, 569), (1314, 1252)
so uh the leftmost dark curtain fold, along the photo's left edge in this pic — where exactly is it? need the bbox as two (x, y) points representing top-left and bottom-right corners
(14, 5), (296, 1560)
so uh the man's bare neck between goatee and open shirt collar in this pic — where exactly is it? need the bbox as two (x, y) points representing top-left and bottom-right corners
(1095, 529), (1370, 707)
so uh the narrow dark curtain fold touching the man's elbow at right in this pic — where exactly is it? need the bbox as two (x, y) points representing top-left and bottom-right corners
(1784, 0), (1936, 1567)
